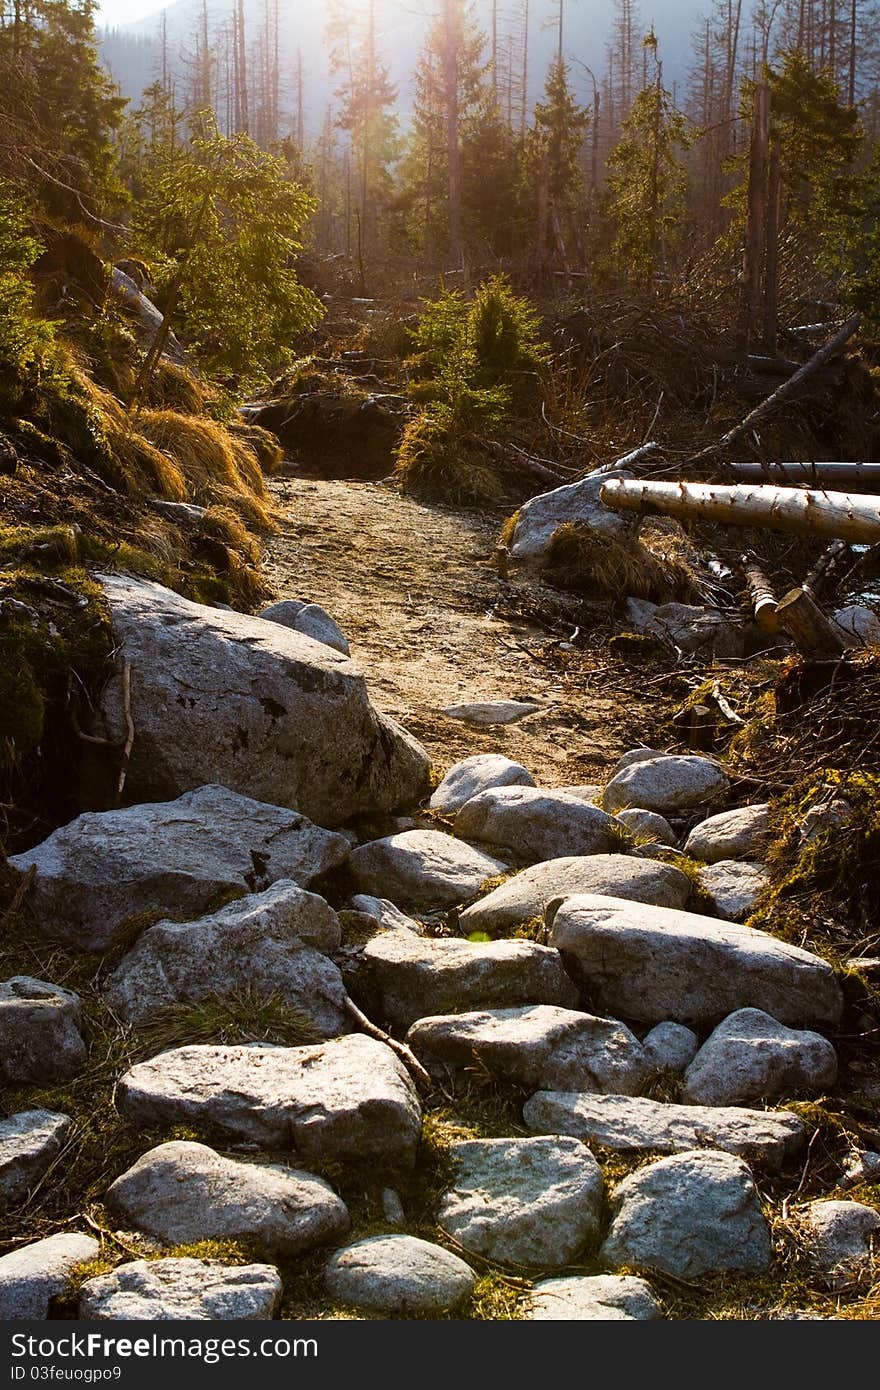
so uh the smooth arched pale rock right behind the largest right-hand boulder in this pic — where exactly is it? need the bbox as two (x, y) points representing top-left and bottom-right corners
(459, 855), (691, 935)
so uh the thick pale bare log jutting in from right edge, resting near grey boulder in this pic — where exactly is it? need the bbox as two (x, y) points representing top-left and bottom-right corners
(599, 478), (880, 543)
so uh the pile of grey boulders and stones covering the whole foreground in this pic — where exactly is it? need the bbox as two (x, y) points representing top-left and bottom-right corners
(0, 580), (880, 1319)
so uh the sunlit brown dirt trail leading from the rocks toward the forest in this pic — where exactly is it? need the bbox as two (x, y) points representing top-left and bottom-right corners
(267, 478), (645, 785)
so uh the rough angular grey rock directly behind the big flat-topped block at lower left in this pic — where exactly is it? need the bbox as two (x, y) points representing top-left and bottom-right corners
(107, 878), (352, 1040)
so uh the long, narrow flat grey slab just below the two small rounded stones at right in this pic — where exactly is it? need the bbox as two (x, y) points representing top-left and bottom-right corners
(523, 1091), (806, 1169)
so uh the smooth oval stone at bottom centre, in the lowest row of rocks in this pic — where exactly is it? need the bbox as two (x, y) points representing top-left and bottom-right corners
(324, 1236), (477, 1315)
